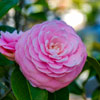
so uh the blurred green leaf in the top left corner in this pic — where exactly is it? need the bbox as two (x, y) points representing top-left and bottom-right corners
(0, 0), (19, 19)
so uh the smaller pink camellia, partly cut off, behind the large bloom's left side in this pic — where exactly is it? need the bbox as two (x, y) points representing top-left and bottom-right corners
(0, 31), (22, 60)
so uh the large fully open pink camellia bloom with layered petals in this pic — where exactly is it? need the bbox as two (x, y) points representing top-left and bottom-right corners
(15, 20), (87, 92)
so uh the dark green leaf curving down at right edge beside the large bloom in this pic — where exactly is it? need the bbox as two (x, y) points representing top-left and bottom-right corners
(87, 56), (100, 79)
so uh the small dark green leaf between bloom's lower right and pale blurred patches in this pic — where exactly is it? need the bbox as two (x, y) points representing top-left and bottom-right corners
(68, 81), (84, 95)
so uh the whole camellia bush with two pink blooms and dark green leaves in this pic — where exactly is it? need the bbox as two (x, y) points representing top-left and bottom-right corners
(0, 0), (100, 100)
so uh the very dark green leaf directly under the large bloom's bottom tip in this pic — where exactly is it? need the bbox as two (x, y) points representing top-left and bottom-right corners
(48, 86), (69, 100)
